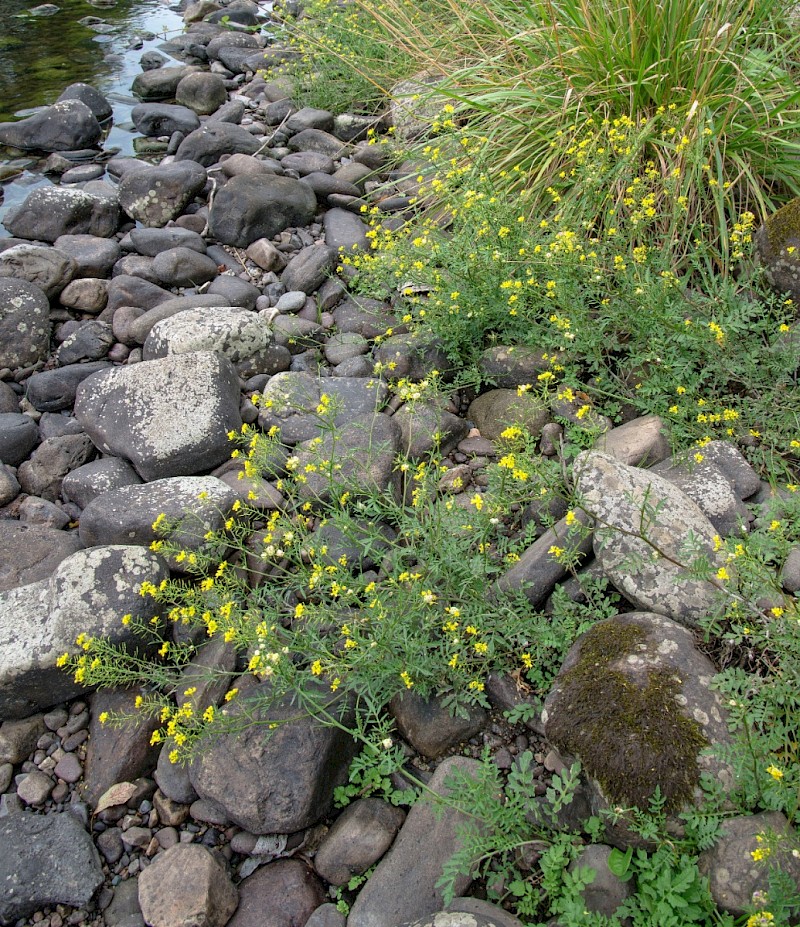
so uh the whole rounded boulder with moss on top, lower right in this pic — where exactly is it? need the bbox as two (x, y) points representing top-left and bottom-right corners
(542, 612), (732, 824)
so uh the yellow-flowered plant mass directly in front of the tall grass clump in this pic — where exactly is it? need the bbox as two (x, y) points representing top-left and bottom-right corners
(343, 108), (797, 474)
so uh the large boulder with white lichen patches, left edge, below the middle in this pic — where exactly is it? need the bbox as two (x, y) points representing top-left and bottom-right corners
(0, 546), (167, 718)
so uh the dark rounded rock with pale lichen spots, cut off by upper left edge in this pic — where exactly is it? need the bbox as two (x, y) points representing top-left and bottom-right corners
(0, 277), (50, 370)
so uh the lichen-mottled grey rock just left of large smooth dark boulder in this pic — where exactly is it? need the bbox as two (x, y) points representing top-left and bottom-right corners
(119, 161), (206, 228)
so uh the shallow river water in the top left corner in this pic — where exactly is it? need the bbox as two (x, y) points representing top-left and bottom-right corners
(0, 0), (183, 232)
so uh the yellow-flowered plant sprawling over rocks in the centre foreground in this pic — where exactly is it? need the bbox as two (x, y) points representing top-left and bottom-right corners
(62, 398), (604, 762)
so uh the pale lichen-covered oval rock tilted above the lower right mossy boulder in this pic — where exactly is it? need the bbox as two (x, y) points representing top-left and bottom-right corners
(573, 451), (731, 626)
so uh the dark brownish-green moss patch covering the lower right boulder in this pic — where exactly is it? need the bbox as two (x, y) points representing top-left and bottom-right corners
(547, 619), (707, 812)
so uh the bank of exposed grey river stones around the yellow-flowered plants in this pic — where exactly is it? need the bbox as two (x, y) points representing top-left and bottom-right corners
(0, 0), (800, 927)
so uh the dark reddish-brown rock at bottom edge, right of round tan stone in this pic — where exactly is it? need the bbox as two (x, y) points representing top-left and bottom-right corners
(228, 859), (326, 927)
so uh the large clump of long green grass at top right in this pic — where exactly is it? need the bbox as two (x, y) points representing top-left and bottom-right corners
(361, 0), (800, 250)
